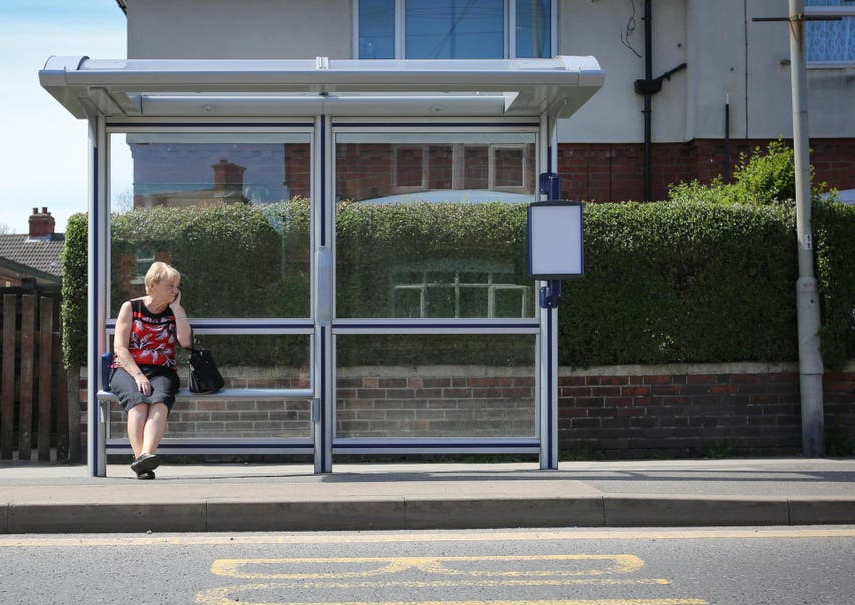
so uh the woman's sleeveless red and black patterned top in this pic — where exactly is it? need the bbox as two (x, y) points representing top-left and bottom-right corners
(112, 298), (178, 370)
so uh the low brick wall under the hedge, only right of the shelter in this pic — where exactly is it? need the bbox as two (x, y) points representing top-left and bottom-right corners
(559, 364), (855, 459)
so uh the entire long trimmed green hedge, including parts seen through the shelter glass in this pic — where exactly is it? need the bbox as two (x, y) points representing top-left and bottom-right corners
(63, 199), (855, 367)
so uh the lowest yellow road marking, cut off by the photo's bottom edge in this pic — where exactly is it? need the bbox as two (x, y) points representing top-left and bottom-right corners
(196, 584), (709, 605)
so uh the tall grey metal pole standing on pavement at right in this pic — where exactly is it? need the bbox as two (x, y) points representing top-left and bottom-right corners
(789, 0), (825, 457)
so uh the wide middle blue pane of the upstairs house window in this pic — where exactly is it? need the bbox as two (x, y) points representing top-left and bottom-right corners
(404, 0), (505, 59)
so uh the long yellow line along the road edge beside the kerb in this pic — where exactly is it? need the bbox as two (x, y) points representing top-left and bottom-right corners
(0, 527), (855, 548)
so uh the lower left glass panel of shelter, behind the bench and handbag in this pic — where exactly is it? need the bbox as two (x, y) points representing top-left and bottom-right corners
(110, 335), (312, 440)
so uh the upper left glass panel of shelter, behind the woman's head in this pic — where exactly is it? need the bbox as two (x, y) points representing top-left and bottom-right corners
(110, 133), (311, 318)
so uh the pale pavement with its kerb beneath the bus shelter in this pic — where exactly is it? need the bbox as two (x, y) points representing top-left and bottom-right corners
(0, 457), (855, 534)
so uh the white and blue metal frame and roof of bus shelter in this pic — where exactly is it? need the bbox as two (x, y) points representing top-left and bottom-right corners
(39, 57), (604, 476)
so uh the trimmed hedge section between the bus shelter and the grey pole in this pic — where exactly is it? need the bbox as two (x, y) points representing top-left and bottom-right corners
(559, 203), (797, 366)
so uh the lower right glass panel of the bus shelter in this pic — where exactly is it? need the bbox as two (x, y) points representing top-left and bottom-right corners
(336, 335), (536, 439)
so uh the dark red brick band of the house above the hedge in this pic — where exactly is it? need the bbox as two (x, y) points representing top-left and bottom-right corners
(558, 139), (855, 202)
